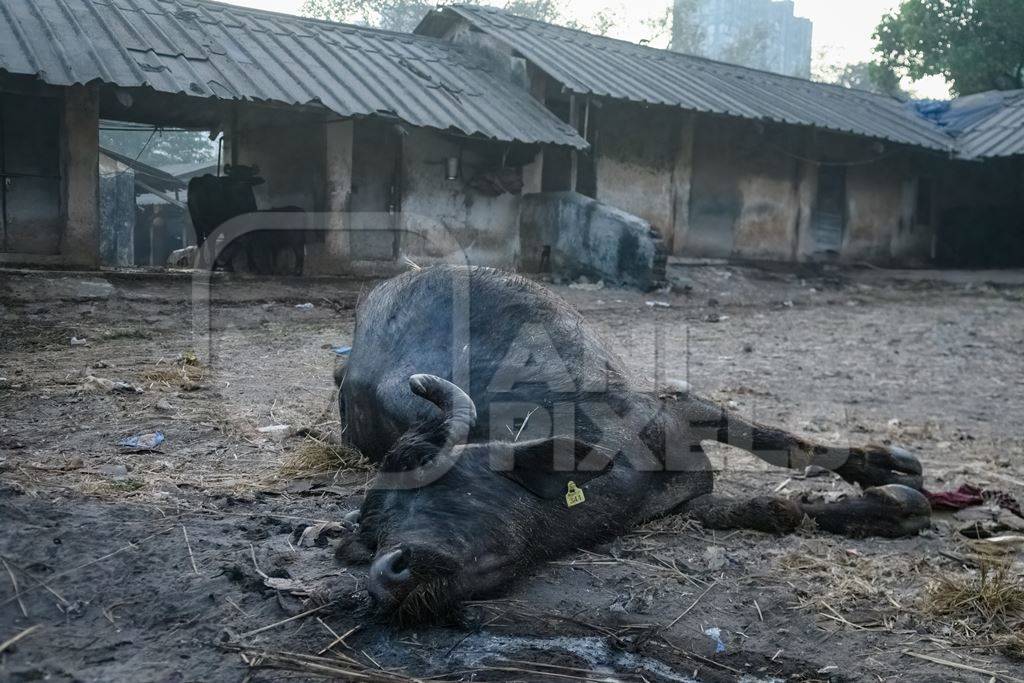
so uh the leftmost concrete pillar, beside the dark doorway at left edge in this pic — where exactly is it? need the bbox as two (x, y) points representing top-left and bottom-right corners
(60, 86), (99, 268)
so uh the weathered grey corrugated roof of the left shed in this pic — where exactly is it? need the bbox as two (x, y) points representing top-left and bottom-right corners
(0, 0), (586, 147)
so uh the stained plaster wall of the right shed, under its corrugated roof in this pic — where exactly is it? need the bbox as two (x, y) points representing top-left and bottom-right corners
(597, 108), (942, 263)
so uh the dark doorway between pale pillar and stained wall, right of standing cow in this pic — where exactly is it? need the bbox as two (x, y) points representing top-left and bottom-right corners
(349, 121), (401, 261)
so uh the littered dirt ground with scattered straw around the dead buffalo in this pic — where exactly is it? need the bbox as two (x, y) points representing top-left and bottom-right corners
(0, 265), (1024, 682)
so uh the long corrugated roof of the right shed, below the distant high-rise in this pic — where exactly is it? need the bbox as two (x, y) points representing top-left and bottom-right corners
(417, 5), (953, 151)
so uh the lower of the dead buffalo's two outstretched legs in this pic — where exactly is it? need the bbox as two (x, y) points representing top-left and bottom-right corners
(684, 484), (932, 538)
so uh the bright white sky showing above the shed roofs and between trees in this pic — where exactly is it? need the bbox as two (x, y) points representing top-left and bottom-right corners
(216, 0), (949, 98)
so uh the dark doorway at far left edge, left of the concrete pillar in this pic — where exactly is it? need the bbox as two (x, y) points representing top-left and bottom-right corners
(0, 94), (63, 254)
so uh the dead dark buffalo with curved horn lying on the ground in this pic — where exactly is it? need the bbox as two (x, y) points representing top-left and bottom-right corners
(338, 267), (931, 621)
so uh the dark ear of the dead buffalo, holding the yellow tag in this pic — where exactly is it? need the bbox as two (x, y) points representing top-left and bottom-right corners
(504, 436), (611, 501)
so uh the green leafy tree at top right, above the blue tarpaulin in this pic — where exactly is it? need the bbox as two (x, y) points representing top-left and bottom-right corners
(874, 0), (1024, 95)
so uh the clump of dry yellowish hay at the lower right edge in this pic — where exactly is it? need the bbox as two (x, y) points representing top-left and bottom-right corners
(922, 562), (1024, 636)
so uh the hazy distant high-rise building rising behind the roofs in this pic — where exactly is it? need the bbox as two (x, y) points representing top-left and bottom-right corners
(672, 0), (813, 78)
